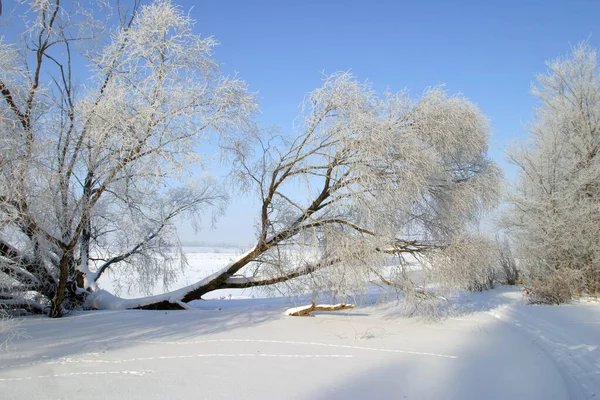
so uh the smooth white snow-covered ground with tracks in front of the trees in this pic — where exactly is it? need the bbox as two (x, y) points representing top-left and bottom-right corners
(0, 250), (600, 400)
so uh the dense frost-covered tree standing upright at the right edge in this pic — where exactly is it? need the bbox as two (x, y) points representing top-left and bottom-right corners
(506, 44), (600, 303)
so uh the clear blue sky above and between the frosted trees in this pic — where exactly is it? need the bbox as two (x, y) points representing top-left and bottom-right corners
(179, 0), (600, 244)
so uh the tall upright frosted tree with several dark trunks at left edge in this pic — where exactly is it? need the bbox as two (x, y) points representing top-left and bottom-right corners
(0, 0), (255, 316)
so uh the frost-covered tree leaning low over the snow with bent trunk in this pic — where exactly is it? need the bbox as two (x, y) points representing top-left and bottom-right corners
(88, 73), (499, 309)
